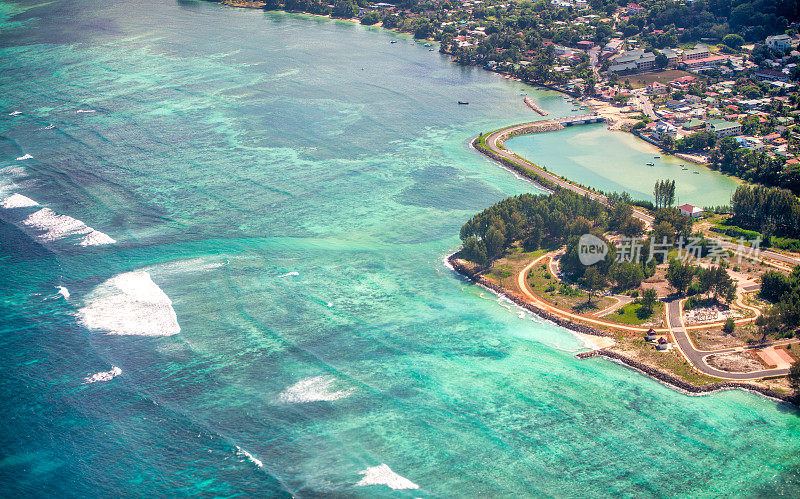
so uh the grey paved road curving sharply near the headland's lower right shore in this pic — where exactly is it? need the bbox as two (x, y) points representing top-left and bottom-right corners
(667, 299), (793, 381)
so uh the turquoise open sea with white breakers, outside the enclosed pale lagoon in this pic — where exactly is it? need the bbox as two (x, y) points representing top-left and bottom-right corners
(0, 0), (800, 497)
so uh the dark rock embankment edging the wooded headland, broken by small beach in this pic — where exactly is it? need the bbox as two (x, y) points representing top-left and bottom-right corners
(447, 253), (795, 403)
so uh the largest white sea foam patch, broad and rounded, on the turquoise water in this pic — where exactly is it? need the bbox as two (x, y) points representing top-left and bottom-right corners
(77, 271), (181, 336)
